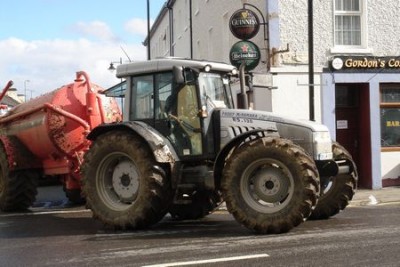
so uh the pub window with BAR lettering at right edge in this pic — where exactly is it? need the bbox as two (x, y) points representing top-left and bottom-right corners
(380, 84), (400, 150)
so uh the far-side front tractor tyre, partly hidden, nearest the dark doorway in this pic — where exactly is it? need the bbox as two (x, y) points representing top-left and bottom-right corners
(310, 142), (358, 220)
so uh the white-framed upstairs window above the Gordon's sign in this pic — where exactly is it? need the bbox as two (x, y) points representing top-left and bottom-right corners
(334, 0), (365, 48)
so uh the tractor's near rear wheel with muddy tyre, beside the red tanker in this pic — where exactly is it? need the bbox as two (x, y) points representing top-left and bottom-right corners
(82, 131), (171, 229)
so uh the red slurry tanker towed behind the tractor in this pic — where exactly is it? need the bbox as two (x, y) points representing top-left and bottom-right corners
(0, 71), (122, 211)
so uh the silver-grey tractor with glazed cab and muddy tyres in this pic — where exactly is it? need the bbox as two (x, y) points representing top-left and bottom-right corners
(82, 58), (358, 234)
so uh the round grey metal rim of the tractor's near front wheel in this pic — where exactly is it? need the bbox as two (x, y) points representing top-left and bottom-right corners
(240, 158), (294, 213)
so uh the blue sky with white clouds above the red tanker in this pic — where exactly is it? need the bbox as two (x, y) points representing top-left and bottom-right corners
(0, 0), (166, 99)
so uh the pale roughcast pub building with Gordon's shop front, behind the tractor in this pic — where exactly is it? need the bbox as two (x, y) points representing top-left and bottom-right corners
(150, 0), (400, 189)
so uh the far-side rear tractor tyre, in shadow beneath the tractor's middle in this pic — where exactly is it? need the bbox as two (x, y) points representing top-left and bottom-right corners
(169, 191), (222, 220)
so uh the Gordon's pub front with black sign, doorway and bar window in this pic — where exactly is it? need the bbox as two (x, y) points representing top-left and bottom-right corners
(321, 56), (400, 189)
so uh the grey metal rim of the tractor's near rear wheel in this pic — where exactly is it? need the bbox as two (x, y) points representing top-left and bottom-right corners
(96, 152), (140, 210)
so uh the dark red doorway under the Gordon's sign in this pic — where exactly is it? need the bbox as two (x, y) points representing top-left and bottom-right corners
(335, 83), (372, 188)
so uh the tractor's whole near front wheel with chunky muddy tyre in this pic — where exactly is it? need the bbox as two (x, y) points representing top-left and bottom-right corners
(222, 137), (319, 234)
